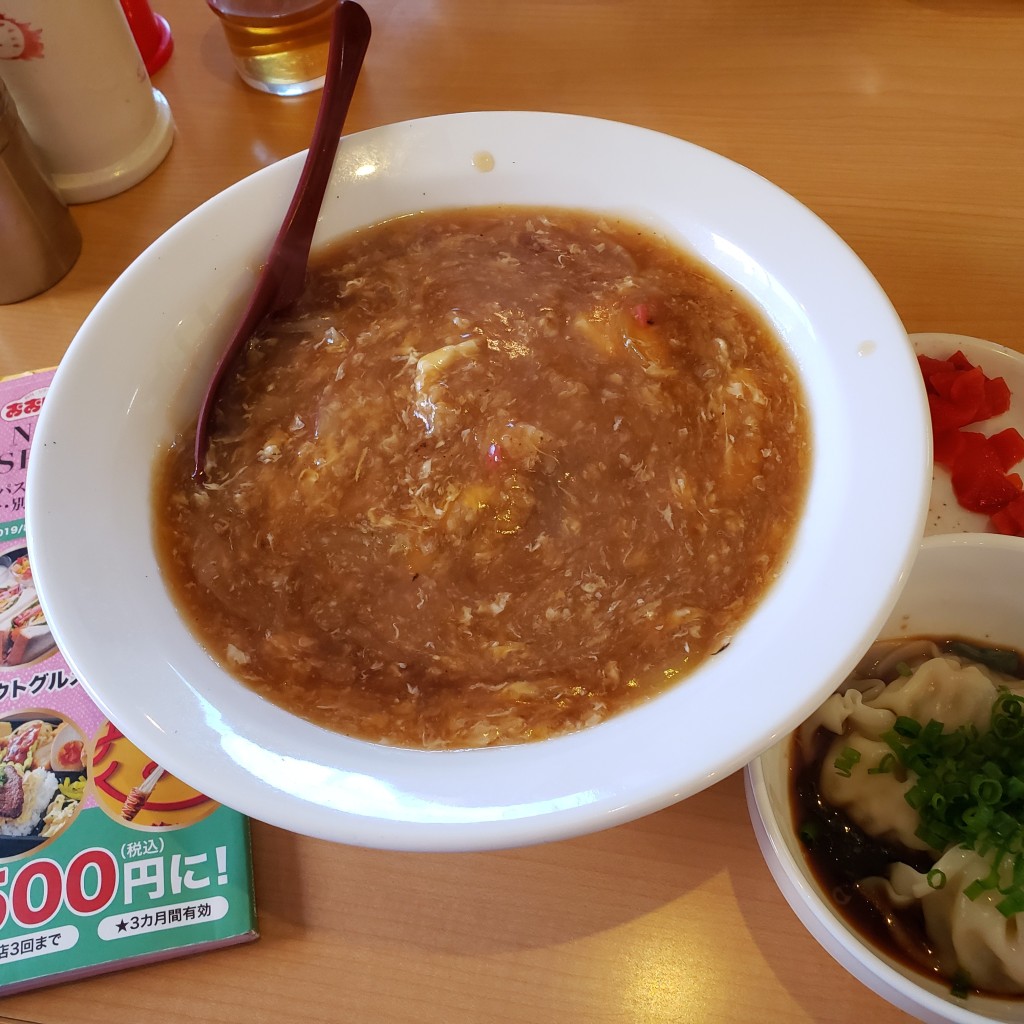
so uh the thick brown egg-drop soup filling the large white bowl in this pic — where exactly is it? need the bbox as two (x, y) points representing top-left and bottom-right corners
(156, 208), (809, 748)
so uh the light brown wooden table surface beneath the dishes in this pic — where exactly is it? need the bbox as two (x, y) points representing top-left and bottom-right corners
(0, 0), (1024, 1024)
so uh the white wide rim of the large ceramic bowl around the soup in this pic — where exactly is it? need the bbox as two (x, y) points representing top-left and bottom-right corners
(28, 112), (931, 850)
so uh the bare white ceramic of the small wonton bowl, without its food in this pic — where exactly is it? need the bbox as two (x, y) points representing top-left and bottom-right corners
(746, 534), (1024, 1024)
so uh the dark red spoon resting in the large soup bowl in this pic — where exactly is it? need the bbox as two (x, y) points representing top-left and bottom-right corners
(193, 0), (371, 481)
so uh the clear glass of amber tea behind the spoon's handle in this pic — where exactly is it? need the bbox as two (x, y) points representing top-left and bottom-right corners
(207, 0), (337, 96)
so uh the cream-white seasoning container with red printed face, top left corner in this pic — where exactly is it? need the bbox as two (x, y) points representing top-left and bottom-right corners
(0, 0), (174, 203)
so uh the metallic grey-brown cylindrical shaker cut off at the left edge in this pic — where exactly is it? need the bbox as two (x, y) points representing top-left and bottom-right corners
(0, 81), (82, 304)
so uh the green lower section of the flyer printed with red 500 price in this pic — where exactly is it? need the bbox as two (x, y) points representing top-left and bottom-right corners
(0, 808), (255, 987)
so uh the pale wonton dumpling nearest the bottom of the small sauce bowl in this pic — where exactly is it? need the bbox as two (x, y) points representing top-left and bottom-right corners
(865, 847), (1024, 992)
